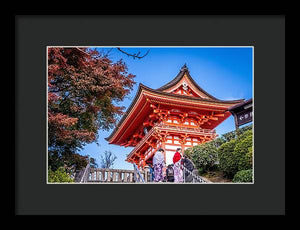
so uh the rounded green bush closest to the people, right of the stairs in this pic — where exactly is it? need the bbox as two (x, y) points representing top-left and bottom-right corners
(185, 141), (218, 172)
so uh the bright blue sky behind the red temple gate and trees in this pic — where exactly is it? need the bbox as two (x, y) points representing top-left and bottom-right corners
(80, 47), (253, 169)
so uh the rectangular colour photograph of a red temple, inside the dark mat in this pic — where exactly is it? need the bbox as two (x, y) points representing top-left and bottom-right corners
(45, 45), (255, 185)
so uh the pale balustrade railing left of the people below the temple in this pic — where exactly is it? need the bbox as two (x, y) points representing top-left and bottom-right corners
(88, 168), (150, 183)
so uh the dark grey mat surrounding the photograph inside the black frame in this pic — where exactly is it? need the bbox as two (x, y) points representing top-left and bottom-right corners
(12, 11), (285, 215)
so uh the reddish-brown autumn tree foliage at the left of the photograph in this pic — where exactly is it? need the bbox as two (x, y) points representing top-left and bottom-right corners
(48, 47), (135, 171)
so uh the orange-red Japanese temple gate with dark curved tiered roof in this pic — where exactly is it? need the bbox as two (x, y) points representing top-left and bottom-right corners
(106, 65), (244, 168)
